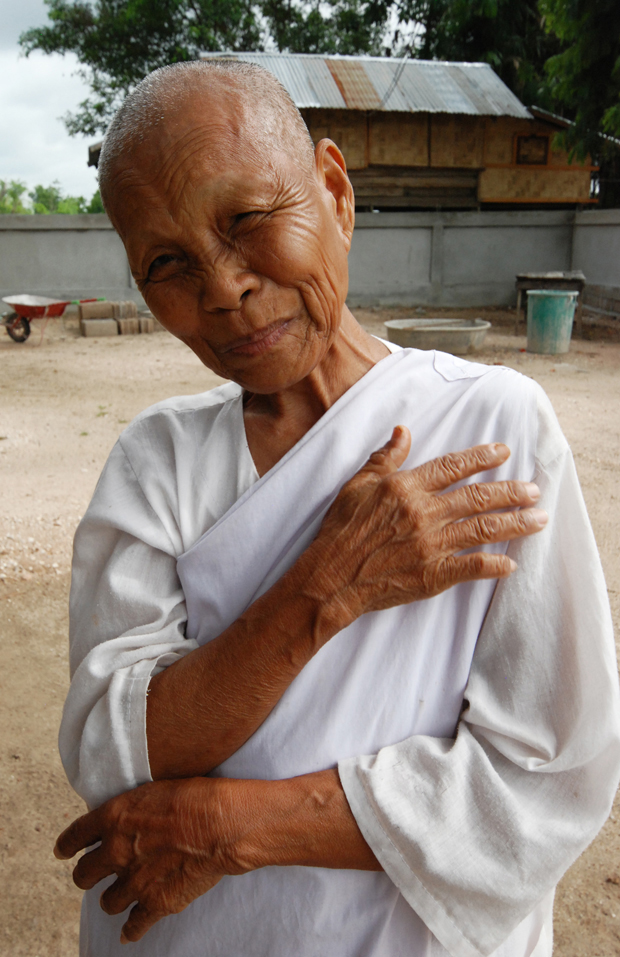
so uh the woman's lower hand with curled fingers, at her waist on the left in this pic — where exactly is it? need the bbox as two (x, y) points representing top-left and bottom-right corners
(54, 778), (246, 943)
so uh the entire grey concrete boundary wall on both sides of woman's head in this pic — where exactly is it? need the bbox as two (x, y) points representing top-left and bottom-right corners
(0, 210), (620, 306)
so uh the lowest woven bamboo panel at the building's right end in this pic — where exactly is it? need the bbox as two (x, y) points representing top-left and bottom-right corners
(478, 166), (590, 203)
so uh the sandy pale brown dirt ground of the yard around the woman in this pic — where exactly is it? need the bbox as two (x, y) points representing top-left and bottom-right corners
(0, 310), (620, 957)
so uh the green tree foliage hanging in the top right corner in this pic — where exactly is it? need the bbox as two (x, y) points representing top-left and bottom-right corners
(540, 0), (620, 158)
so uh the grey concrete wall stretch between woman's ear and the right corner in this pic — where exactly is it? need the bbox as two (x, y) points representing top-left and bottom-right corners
(349, 210), (576, 306)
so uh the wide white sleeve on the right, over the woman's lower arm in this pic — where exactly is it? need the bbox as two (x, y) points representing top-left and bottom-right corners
(339, 386), (620, 957)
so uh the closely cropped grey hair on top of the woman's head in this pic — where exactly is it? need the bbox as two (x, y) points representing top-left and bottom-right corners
(99, 59), (314, 203)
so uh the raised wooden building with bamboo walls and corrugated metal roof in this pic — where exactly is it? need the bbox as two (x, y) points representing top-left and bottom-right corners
(89, 53), (596, 210)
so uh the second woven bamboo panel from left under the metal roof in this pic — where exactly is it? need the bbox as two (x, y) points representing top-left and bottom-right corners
(368, 113), (429, 166)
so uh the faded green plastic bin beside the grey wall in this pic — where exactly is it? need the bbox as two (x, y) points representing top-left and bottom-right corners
(527, 289), (579, 356)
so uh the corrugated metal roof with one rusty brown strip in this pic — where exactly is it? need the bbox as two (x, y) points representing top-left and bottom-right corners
(204, 53), (531, 119)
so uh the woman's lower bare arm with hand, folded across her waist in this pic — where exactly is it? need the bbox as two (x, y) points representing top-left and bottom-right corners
(54, 770), (381, 942)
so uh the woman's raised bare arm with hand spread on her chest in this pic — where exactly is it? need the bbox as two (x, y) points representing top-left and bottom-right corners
(147, 427), (544, 780)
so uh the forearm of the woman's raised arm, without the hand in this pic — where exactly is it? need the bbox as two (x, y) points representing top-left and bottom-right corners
(146, 547), (350, 780)
